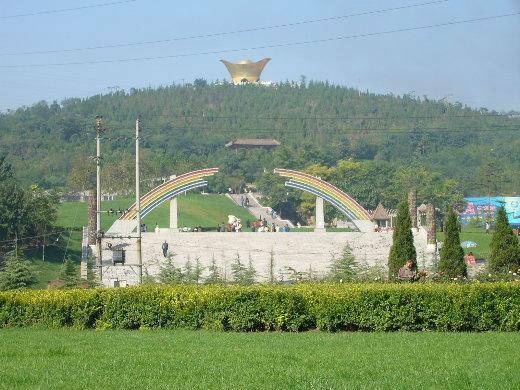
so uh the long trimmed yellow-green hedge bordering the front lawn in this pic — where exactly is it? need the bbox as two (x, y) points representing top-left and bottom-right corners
(0, 282), (520, 331)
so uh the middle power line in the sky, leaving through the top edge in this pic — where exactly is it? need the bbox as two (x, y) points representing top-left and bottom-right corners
(0, 0), (450, 56)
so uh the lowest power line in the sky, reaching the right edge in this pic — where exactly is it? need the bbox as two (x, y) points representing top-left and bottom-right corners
(0, 12), (520, 69)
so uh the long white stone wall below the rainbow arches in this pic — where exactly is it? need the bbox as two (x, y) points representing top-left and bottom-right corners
(97, 229), (433, 286)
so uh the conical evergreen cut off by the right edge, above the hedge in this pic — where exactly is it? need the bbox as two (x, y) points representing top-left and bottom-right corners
(489, 207), (520, 272)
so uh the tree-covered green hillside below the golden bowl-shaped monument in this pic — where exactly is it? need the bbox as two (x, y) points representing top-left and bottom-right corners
(0, 80), (520, 195)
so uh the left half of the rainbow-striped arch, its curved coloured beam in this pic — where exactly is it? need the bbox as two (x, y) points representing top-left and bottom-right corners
(119, 168), (218, 221)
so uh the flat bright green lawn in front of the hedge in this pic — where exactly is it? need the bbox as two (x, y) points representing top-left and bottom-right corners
(0, 329), (520, 389)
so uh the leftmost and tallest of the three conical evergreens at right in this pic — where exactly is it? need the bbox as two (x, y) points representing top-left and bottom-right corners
(388, 199), (417, 278)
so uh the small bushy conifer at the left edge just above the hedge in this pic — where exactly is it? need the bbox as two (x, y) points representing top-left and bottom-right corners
(0, 251), (37, 290)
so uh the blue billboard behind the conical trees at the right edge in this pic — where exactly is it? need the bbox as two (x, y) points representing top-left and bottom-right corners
(460, 196), (520, 228)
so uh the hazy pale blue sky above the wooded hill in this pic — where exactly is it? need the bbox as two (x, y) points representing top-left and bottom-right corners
(0, 0), (520, 111)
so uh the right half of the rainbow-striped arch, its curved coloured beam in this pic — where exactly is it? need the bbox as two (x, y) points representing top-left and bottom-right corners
(274, 168), (370, 223)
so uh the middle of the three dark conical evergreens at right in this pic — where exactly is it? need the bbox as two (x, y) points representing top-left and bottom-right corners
(439, 207), (467, 278)
